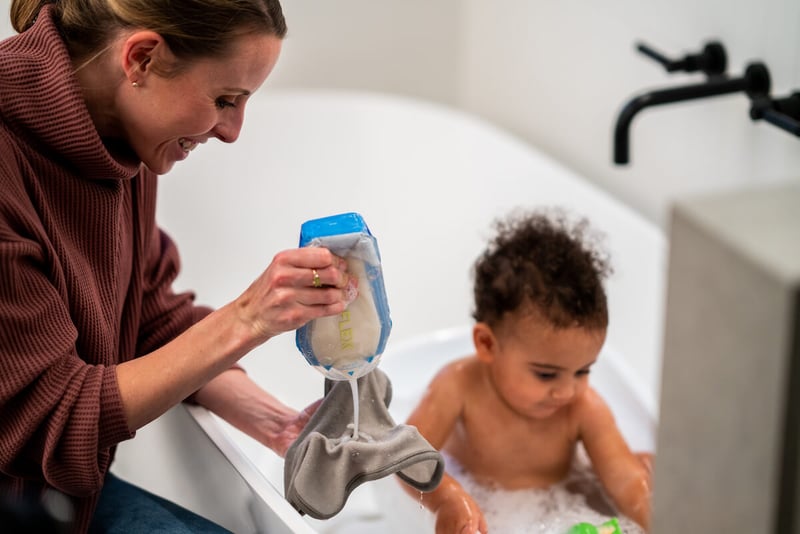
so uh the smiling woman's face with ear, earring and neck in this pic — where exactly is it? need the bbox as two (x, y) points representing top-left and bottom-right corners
(108, 30), (281, 174)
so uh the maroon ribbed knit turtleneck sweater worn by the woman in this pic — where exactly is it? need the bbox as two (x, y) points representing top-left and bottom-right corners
(0, 7), (208, 532)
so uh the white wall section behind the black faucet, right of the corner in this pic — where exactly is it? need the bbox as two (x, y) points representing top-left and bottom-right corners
(459, 0), (800, 226)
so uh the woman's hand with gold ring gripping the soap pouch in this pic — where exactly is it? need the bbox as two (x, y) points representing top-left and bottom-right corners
(233, 247), (358, 343)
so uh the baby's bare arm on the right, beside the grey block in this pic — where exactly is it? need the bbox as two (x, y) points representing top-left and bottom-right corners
(578, 388), (651, 530)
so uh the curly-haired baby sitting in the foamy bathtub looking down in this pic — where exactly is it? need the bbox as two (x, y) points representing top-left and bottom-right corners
(408, 212), (651, 534)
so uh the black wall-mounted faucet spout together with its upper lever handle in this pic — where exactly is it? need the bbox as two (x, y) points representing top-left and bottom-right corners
(614, 41), (774, 165)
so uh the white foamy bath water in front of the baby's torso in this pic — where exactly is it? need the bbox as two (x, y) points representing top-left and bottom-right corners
(445, 446), (645, 534)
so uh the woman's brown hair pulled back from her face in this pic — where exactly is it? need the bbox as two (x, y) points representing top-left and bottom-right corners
(11, 0), (286, 65)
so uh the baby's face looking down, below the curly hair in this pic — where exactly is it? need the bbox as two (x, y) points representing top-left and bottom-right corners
(490, 315), (605, 419)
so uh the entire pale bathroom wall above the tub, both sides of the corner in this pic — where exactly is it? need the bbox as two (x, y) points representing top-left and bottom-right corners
(270, 0), (800, 228)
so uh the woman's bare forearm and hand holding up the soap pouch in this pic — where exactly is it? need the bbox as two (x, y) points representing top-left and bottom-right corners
(116, 247), (354, 430)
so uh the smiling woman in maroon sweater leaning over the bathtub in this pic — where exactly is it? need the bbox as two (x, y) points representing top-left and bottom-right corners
(0, 0), (357, 532)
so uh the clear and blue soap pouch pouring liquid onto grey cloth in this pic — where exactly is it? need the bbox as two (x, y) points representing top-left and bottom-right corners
(296, 212), (392, 380)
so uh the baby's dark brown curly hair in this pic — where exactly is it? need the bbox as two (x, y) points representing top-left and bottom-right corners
(472, 209), (611, 329)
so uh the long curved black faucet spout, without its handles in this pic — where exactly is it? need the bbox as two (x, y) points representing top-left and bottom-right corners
(614, 63), (770, 165)
